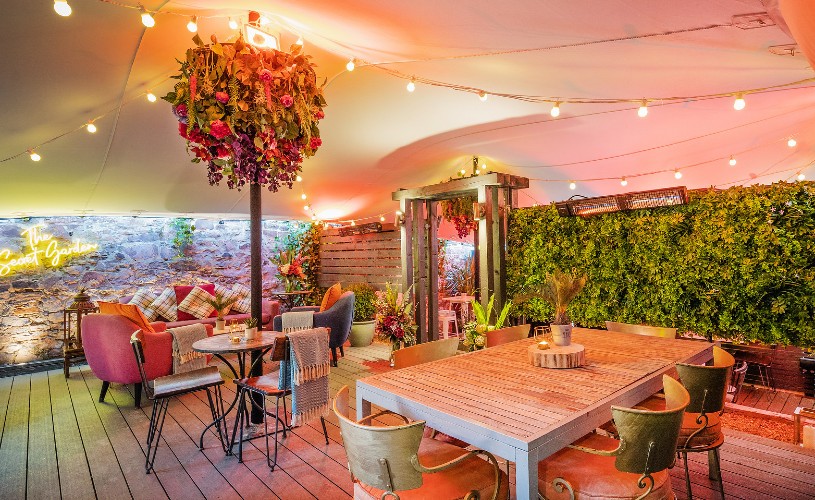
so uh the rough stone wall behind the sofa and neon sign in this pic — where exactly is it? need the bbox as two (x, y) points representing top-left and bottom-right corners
(0, 217), (306, 365)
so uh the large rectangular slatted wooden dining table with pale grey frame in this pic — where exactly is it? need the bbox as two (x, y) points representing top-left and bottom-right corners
(356, 328), (713, 500)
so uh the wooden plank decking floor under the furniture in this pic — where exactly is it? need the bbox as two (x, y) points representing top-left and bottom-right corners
(0, 344), (815, 500)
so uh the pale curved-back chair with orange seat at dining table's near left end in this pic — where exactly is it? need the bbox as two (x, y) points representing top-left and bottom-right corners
(334, 386), (508, 500)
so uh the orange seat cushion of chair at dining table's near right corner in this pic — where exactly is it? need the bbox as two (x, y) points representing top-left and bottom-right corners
(538, 434), (674, 500)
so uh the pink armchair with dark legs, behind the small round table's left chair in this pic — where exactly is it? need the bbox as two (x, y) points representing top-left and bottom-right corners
(82, 314), (212, 407)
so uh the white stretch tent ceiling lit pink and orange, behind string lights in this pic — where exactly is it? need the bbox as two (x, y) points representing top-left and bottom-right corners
(0, 0), (815, 221)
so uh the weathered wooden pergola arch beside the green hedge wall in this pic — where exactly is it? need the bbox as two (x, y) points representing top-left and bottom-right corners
(393, 172), (529, 342)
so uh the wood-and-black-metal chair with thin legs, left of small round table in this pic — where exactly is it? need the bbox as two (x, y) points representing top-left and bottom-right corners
(130, 330), (226, 474)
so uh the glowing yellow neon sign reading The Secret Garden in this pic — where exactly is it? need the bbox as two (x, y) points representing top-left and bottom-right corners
(0, 224), (99, 277)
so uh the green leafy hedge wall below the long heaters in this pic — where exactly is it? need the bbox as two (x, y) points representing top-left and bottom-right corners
(508, 182), (815, 346)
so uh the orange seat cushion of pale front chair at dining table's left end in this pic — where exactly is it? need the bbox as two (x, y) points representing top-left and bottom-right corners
(354, 438), (508, 500)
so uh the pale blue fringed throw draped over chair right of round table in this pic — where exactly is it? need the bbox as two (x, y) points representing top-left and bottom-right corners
(280, 328), (331, 426)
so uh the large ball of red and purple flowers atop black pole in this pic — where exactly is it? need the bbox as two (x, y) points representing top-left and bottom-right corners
(163, 35), (326, 191)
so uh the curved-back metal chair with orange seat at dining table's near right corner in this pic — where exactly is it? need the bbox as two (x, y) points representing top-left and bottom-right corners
(538, 375), (689, 499)
